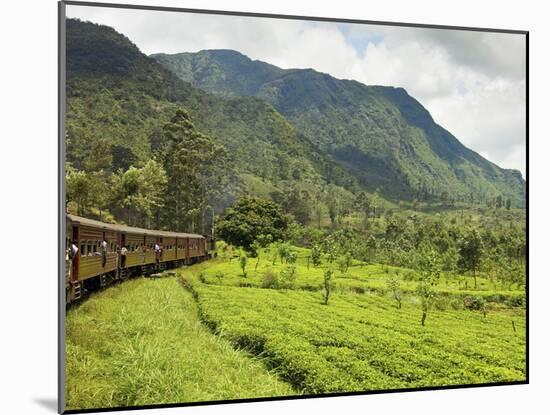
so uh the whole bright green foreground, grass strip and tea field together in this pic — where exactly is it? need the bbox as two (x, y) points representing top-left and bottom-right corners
(67, 248), (526, 409)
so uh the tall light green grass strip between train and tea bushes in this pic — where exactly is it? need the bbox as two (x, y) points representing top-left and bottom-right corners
(66, 278), (295, 409)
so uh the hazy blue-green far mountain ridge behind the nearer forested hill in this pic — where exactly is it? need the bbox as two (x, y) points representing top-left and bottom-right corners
(151, 50), (525, 206)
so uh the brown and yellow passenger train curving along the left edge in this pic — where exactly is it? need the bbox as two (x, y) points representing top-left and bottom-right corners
(65, 213), (216, 304)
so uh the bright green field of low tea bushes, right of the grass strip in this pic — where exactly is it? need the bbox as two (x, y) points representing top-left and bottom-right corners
(181, 260), (525, 393)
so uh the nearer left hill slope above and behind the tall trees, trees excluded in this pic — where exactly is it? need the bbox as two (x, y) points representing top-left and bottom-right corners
(67, 19), (357, 201)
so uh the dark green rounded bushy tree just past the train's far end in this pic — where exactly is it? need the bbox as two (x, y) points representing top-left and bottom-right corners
(217, 196), (288, 250)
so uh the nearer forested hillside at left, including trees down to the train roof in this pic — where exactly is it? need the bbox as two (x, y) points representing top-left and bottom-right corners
(67, 19), (359, 231)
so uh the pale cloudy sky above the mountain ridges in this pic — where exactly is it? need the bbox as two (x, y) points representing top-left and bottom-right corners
(67, 5), (526, 177)
